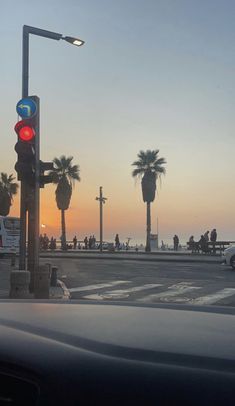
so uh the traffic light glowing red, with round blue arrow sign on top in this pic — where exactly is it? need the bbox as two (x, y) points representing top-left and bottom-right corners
(15, 96), (39, 186)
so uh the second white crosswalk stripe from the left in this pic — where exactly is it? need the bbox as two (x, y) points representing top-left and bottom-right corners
(83, 283), (162, 300)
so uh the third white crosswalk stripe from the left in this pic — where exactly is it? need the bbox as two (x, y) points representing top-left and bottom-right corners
(137, 282), (201, 303)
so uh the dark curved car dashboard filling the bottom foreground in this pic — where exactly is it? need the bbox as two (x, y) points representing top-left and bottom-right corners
(0, 300), (235, 406)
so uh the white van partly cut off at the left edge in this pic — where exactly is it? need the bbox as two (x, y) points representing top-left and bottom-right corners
(0, 216), (20, 254)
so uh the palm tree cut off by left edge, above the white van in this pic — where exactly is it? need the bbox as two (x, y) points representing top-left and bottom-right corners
(0, 172), (19, 216)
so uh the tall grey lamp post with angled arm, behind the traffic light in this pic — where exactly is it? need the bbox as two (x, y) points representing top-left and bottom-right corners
(19, 25), (84, 276)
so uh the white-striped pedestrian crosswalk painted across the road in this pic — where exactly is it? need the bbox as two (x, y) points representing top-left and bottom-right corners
(69, 280), (235, 305)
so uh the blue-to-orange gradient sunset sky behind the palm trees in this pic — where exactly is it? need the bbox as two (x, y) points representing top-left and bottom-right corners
(0, 0), (235, 241)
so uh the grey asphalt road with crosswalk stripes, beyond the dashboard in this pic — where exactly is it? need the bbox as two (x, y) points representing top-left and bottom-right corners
(41, 258), (235, 306)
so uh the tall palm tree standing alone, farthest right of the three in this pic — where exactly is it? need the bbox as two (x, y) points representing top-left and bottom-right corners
(132, 149), (166, 252)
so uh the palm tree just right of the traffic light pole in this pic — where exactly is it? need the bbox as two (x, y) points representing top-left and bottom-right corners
(50, 155), (81, 250)
